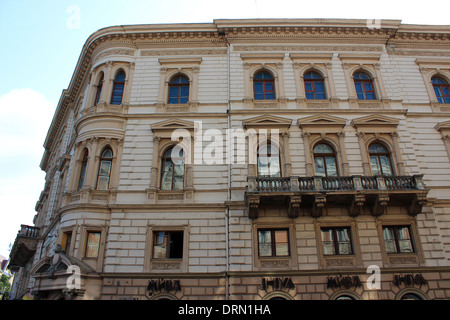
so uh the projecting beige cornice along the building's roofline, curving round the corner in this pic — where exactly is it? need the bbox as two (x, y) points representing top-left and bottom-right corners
(40, 19), (450, 170)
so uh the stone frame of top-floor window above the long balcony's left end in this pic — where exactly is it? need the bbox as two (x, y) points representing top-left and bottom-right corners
(241, 53), (287, 109)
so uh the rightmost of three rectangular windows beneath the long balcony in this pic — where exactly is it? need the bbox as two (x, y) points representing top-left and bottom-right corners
(383, 226), (414, 253)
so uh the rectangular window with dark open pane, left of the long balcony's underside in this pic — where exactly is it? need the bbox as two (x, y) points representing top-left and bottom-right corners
(153, 231), (183, 259)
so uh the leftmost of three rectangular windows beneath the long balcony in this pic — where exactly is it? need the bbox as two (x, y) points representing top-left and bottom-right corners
(258, 229), (289, 257)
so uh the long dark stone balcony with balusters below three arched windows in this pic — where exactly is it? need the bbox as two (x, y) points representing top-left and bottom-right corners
(245, 175), (428, 219)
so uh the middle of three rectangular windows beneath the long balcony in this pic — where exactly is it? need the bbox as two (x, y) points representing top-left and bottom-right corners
(321, 227), (353, 255)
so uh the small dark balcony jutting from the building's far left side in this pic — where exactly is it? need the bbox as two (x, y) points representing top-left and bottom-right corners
(9, 224), (39, 271)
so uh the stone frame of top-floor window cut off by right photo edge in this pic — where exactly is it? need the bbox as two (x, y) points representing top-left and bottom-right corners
(415, 57), (450, 112)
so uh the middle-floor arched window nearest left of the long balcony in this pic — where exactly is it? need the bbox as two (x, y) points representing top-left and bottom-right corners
(161, 148), (184, 190)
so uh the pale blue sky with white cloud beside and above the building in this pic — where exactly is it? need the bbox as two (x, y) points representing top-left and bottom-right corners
(0, 0), (450, 257)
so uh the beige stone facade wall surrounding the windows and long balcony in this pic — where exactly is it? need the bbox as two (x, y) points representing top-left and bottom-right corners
(26, 22), (450, 299)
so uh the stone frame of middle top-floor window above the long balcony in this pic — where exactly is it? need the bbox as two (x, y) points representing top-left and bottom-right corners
(289, 53), (338, 109)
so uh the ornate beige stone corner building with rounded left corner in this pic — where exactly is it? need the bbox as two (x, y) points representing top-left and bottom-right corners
(10, 19), (450, 300)
